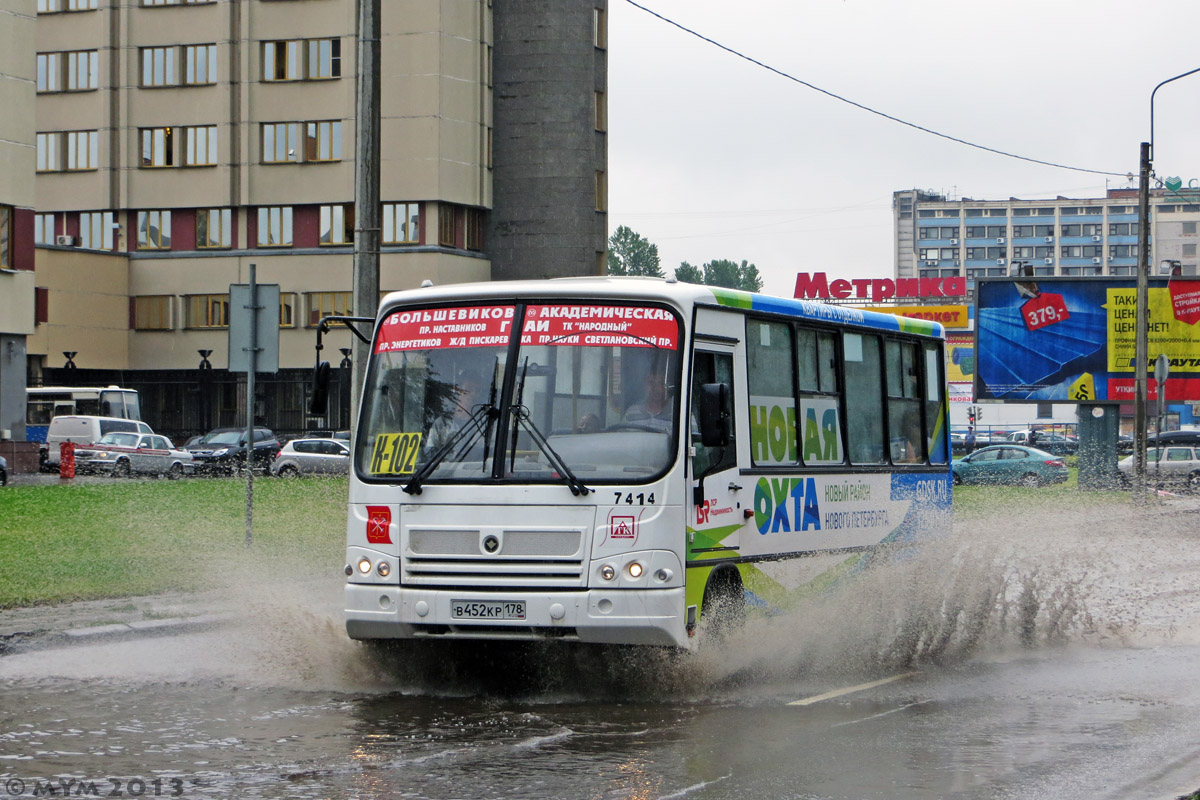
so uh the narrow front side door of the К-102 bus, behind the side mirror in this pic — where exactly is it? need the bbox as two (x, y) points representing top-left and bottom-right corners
(688, 309), (754, 568)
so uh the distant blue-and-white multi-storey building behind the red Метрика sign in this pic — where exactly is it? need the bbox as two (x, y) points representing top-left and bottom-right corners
(892, 190), (1200, 285)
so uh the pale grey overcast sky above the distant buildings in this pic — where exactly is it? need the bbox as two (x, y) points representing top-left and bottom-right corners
(608, 0), (1200, 296)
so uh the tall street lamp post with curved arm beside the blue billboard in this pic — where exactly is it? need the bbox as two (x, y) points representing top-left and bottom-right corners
(1133, 67), (1200, 503)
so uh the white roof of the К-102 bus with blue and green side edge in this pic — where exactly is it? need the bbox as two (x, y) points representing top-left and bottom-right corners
(379, 276), (944, 338)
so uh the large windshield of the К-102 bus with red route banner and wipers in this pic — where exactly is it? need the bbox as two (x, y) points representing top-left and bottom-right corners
(356, 302), (680, 483)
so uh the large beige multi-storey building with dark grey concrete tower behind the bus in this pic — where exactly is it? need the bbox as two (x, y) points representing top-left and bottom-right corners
(25, 0), (607, 435)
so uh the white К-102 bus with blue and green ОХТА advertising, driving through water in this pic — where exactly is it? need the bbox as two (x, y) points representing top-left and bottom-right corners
(333, 278), (950, 648)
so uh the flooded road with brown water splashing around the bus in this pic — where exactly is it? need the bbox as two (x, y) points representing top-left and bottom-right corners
(0, 503), (1200, 800)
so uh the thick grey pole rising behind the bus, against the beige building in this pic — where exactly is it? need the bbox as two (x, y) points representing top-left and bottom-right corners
(350, 0), (382, 431)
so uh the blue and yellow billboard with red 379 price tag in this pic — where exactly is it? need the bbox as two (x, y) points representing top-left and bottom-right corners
(974, 278), (1200, 403)
